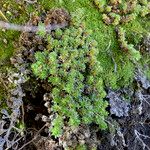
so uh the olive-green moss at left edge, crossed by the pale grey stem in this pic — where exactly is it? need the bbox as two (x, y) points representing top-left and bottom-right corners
(0, 0), (28, 64)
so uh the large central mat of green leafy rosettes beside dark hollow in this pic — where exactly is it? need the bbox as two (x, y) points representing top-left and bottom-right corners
(31, 10), (108, 137)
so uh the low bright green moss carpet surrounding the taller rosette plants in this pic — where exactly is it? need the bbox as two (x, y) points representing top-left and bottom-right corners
(0, 0), (150, 98)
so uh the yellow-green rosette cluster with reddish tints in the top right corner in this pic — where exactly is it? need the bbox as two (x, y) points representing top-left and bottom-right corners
(93, 0), (150, 25)
